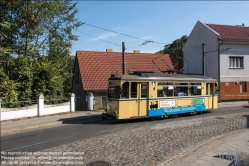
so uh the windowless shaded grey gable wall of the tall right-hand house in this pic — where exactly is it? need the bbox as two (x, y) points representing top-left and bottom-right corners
(183, 21), (218, 79)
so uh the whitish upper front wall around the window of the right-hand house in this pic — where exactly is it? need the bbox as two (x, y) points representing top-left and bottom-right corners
(220, 44), (249, 82)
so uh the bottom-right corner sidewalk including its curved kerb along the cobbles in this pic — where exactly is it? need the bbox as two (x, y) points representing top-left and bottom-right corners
(162, 129), (249, 166)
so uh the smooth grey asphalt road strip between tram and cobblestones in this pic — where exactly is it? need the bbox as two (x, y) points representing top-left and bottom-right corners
(1, 107), (249, 152)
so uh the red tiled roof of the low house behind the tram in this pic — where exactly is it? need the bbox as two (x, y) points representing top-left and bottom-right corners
(76, 51), (179, 90)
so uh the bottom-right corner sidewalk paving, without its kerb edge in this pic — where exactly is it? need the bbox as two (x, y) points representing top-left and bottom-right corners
(191, 129), (249, 166)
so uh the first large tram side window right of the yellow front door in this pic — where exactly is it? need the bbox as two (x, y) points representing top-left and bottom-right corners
(157, 82), (173, 97)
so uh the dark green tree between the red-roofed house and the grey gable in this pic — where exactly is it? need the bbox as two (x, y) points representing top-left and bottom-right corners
(156, 35), (188, 69)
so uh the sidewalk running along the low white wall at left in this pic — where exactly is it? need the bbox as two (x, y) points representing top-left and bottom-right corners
(1, 111), (104, 134)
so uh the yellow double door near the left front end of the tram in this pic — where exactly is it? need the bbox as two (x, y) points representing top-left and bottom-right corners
(130, 82), (148, 117)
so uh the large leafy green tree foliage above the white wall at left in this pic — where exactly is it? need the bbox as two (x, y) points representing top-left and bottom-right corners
(0, 0), (82, 102)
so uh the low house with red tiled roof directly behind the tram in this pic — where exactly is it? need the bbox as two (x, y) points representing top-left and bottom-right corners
(73, 49), (179, 110)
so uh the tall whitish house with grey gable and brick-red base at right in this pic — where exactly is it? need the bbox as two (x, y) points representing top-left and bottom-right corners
(182, 21), (249, 101)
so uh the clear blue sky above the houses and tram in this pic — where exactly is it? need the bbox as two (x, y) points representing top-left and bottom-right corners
(71, 1), (249, 55)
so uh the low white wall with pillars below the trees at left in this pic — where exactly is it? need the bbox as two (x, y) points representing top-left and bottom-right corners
(0, 93), (75, 121)
